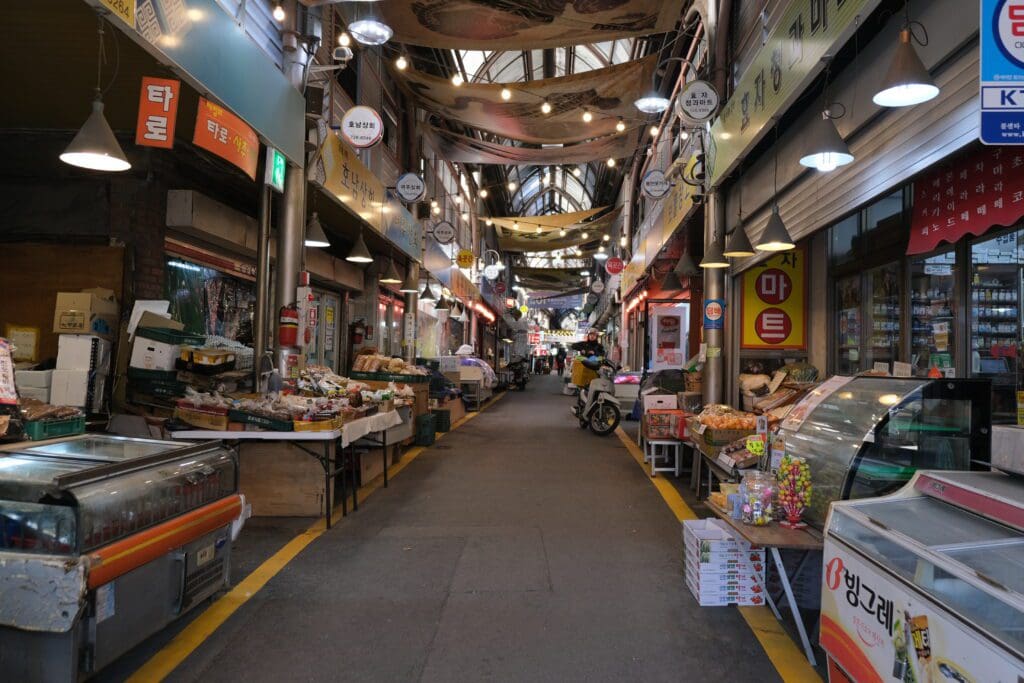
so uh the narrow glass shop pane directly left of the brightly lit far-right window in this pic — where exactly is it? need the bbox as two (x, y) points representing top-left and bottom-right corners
(910, 249), (959, 377)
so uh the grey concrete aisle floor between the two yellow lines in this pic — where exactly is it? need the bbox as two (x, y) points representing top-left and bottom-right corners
(116, 376), (779, 683)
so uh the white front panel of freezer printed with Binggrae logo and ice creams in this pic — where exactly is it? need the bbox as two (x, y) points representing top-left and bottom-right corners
(820, 541), (1024, 683)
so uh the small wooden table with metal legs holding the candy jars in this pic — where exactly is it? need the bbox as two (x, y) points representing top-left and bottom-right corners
(707, 501), (824, 667)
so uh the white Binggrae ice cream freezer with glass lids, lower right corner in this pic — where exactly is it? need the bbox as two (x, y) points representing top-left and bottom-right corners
(821, 471), (1024, 683)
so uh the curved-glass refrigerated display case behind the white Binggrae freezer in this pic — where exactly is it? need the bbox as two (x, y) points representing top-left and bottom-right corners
(780, 377), (991, 528)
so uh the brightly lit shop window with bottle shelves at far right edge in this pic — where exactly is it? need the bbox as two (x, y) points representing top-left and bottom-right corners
(971, 230), (1024, 424)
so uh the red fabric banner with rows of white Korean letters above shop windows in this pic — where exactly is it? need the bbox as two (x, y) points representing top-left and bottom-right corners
(906, 147), (1024, 254)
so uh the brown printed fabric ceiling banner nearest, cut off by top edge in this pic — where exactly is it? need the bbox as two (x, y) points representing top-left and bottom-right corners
(378, 0), (683, 50)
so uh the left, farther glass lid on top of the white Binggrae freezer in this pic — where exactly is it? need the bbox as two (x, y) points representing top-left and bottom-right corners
(858, 497), (1020, 547)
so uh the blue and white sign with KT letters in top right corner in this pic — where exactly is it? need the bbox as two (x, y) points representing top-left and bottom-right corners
(979, 0), (1024, 144)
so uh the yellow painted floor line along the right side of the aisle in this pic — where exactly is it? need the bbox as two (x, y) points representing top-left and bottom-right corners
(615, 427), (821, 683)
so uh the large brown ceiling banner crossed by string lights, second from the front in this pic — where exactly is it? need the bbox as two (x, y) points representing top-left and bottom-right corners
(402, 55), (657, 144)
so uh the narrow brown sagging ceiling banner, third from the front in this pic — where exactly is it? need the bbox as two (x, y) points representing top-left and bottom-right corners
(425, 122), (637, 166)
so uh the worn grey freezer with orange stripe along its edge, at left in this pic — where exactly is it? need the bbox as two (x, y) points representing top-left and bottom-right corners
(0, 434), (245, 681)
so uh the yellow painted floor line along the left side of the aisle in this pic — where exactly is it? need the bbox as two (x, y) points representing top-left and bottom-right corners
(128, 392), (505, 683)
